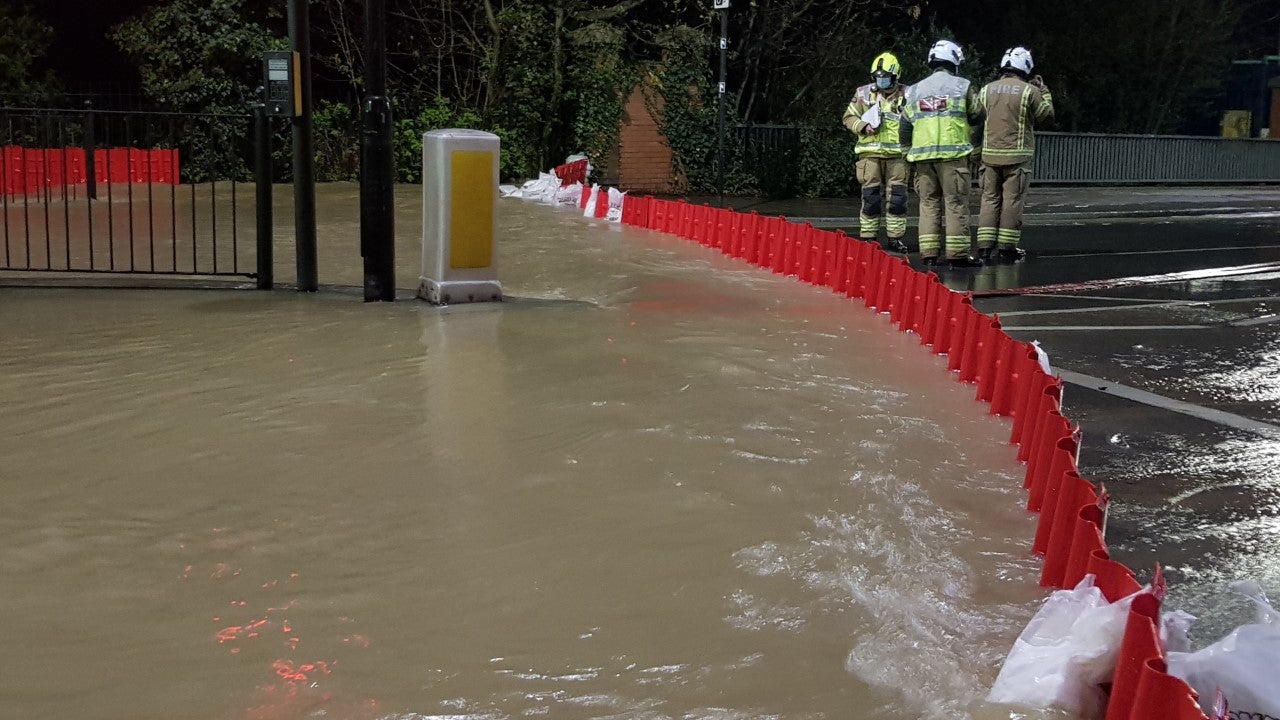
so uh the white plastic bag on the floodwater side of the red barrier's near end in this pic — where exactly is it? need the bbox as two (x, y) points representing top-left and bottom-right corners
(987, 575), (1135, 717)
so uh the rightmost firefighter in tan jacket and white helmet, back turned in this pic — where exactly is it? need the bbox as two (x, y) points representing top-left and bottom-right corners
(978, 47), (1053, 263)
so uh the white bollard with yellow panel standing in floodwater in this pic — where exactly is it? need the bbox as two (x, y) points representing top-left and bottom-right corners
(417, 129), (502, 305)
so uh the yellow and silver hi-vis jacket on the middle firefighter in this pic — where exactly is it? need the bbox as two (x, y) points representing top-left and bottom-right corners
(901, 70), (982, 163)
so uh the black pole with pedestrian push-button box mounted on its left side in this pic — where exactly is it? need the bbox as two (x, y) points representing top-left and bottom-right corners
(288, 0), (319, 292)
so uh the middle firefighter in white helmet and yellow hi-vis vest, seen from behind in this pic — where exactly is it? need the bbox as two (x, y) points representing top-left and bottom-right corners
(901, 40), (982, 268)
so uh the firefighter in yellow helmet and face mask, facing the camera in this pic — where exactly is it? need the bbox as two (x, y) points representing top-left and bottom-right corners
(844, 53), (908, 254)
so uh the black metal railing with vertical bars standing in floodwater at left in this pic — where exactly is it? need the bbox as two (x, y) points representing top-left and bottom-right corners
(0, 105), (256, 277)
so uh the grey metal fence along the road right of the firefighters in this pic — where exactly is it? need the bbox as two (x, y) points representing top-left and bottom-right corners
(1032, 132), (1280, 184)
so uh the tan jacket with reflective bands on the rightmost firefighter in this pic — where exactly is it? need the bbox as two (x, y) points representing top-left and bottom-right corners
(978, 76), (1053, 165)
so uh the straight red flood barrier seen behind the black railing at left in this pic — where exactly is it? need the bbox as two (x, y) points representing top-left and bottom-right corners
(0, 145), (182, 195)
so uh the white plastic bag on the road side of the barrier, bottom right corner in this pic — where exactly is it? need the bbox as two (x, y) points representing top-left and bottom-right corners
(1166, 580), (1280, 717)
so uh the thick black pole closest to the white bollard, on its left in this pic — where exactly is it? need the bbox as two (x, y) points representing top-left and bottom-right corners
(360, 0), (396, 302)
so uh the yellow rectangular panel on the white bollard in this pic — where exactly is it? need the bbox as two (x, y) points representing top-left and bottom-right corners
(449, 150), (495, 269)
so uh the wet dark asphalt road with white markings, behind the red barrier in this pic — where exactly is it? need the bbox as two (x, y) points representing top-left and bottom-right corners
(742, 187), (1280, 638)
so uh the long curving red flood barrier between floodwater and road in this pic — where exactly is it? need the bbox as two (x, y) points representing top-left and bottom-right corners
(593, 188), (1207, 720)
